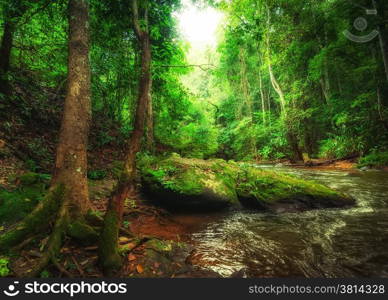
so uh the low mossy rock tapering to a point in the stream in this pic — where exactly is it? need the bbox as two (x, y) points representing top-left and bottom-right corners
(236, 167), (355, 212)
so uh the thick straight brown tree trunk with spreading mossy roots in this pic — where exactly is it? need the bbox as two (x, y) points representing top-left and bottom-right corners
(0, 0), (96, 276)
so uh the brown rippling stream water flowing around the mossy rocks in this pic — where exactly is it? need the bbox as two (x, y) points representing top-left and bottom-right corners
(171, 166), (388, 277)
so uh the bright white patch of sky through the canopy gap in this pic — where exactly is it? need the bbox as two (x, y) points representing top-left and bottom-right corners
(176, 0), (223, 49)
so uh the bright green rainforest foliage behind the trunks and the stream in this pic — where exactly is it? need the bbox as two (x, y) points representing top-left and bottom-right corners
(0, 0), (388, 165)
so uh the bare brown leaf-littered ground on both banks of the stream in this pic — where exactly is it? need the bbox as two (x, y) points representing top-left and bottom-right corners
(0, 130), (388, 277)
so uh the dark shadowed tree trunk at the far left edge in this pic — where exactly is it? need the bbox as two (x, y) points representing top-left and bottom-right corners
(0, 20), (15, 94)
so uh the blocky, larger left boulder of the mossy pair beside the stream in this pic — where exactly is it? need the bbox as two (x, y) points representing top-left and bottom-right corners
(139, 155), (239, 210)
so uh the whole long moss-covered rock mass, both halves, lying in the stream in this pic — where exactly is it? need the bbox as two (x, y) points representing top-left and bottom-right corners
(139, 155), (355, 213)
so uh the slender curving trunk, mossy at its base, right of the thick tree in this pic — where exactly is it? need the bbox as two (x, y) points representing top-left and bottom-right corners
(99, 0), (151, 275)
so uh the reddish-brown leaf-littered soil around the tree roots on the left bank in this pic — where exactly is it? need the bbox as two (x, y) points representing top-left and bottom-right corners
(0, 149), (219, 278)
